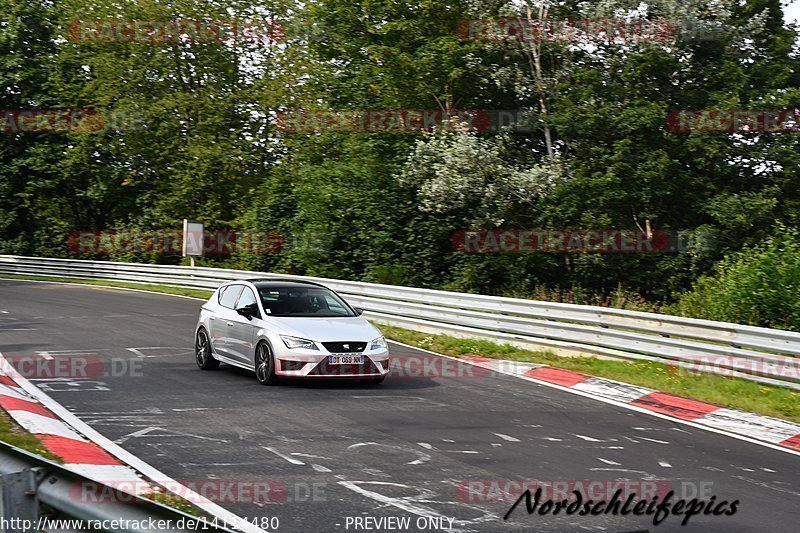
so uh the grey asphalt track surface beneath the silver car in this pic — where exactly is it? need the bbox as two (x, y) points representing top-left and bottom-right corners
(0, 281), (800, 533)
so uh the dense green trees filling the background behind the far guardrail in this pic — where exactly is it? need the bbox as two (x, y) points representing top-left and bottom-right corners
(0, 0), (800, 314)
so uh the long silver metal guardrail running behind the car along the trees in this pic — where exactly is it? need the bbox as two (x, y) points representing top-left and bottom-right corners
(0, 251), (800, 390)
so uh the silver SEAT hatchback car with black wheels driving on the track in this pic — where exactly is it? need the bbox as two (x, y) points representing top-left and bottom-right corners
(195, 279), (389, 385)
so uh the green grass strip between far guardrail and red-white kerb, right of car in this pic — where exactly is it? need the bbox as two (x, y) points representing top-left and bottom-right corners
(379, 325), (800, 422)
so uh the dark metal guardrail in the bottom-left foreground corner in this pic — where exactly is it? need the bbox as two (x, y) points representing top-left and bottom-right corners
(0, 441), (231, 533)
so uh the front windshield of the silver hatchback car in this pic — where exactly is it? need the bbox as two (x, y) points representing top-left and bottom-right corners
(258, 287), (356, 317)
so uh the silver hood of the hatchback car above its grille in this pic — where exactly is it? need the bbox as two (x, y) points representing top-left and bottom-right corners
(267, 317), (381, 342)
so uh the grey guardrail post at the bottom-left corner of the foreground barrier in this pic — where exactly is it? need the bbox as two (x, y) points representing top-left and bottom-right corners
(0, 468), (39, 533)
